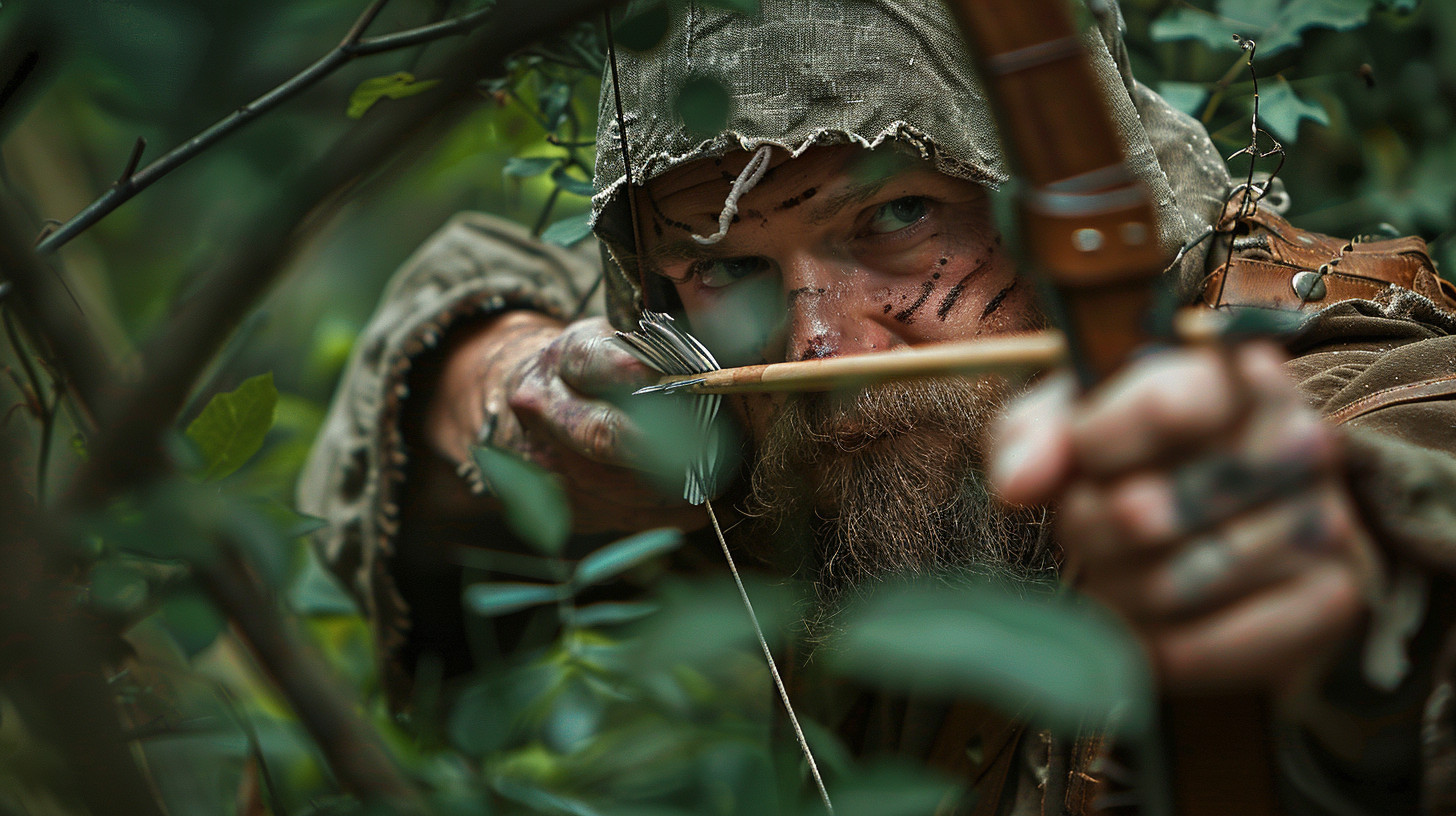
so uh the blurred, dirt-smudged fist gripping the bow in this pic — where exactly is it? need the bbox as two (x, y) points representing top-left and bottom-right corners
(992, 344), (1377, 691)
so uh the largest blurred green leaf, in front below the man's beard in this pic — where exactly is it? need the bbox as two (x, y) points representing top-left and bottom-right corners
(830, 584), (1153, 740)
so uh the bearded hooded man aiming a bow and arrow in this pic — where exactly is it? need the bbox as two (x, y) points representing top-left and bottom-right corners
(303, 0), (1456, 813)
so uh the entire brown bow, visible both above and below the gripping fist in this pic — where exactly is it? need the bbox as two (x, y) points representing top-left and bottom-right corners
(949, 0), (1280, 816)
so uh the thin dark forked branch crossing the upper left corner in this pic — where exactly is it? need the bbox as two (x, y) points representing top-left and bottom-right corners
(36, 0), (494, 255)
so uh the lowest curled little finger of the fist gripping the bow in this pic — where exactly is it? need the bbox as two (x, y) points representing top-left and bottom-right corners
(1150, 564), (1364, 692)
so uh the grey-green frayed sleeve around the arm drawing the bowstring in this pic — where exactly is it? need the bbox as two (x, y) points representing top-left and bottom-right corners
(297, 213), (601, 682)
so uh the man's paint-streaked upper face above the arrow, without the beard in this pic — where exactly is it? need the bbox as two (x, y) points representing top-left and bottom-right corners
(638, 146), (1038, 442)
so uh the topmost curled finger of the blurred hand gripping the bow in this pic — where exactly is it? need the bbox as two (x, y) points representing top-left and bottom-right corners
(1072, 348), (1243, 475)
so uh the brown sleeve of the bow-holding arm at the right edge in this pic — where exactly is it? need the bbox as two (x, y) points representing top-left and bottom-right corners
(1278, 289), (1456, 813)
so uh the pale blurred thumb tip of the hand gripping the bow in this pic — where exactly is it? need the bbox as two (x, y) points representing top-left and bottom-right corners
(987, 374), (1076, 506)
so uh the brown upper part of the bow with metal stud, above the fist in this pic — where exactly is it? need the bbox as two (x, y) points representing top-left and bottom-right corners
(951, 0), (1168, 386)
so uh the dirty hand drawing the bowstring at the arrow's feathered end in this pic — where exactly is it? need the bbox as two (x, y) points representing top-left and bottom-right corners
(428, 312), (706, 533)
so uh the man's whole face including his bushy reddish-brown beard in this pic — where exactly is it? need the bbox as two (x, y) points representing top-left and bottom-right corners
(638, 146), (1038, 597)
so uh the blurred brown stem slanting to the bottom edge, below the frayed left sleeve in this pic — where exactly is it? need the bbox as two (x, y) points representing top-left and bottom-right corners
(195, 541), (425, 813)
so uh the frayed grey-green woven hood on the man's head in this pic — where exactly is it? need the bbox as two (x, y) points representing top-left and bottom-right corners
(593, 0), (1229, 328)
